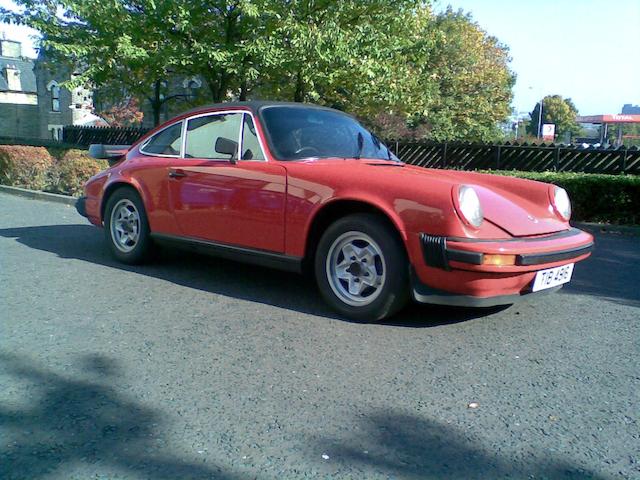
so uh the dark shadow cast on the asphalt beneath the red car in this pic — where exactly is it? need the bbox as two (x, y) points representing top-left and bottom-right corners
(0, 224), (616, 328)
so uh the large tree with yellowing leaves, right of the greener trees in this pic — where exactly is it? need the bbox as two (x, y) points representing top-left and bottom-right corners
(364, 8), (515, 141)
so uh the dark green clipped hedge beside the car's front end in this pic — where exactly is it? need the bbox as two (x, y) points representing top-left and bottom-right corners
(488, 170), (640, 224)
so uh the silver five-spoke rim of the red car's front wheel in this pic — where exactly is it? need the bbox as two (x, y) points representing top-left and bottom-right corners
(326, 232), (386, 306)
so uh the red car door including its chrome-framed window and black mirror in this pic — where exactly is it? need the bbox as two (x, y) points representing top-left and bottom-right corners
(168, 110), (286, 252)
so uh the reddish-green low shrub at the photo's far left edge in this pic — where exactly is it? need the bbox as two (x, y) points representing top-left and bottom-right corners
(0, 145), (54, 190)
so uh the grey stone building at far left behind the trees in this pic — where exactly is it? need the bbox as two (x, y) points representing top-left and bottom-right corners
(0, 39), (96, 140)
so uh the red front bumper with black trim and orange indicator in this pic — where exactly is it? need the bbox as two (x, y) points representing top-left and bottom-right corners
(407, 228), (593, 306)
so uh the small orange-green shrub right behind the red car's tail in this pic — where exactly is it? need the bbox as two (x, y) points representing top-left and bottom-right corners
(48, 149), (109, 196)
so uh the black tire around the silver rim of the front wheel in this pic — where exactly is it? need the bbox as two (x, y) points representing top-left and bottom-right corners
(314, 213), (409, 322)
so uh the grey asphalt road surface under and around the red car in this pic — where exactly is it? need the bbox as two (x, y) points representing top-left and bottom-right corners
(0, 194), (640, 480)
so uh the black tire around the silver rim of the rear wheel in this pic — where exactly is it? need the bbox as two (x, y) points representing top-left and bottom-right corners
(104, 187), (152, 265)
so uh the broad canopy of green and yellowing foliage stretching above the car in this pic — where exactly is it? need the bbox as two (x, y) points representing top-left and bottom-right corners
(0, 0), (514, 140)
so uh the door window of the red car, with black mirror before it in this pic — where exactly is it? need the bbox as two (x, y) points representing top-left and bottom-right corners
(184, 113), (242, 160)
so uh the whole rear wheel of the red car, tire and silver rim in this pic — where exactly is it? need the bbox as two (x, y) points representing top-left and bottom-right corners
(104, 187), (151, 264)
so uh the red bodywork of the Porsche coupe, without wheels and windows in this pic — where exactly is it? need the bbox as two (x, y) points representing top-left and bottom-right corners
(81, 102), (593, 312)
